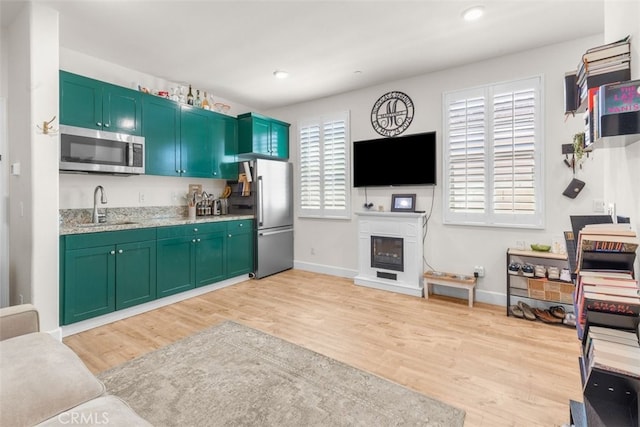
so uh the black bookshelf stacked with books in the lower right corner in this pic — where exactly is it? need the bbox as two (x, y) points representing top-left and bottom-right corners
(569, 224), (640, 427)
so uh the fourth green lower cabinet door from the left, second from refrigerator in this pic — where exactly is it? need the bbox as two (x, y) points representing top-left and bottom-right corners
(195, 232), (225, 286)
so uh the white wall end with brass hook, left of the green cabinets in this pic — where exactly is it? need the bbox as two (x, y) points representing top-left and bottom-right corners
(6, 3), (59, 331)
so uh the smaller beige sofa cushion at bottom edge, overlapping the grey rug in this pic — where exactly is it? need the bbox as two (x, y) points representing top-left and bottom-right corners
(38, 395), (151, 427)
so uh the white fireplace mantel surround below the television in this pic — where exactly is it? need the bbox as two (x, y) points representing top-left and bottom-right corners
(354, 211), (426, 297)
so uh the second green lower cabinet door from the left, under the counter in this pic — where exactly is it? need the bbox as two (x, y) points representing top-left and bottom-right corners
(116, 240), (156, 310)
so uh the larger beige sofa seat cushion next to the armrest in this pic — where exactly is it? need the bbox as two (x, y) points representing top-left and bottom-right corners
(0, 332), (105, 426)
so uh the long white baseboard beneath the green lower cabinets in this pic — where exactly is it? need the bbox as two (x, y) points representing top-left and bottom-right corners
(59, 275), (249, 337)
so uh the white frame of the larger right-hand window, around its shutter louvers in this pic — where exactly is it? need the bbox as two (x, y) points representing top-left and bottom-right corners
(442, 75), (545, 229)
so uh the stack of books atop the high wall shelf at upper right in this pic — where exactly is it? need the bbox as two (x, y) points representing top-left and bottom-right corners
(577, 36), (631, 106)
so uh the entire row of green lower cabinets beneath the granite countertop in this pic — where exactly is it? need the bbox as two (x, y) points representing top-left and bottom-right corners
(60, 219), (253, 325)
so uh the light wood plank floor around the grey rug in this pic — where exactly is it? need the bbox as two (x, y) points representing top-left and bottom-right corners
(64, 270), (582, 427)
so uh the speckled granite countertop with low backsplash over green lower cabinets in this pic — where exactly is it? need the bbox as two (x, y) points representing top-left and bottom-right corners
(59, 208), (254, 236)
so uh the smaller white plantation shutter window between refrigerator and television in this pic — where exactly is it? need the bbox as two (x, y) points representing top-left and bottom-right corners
(298, 113), (351, 219)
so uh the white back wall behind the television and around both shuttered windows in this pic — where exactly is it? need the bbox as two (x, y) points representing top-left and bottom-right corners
(268, 37), (604, 304)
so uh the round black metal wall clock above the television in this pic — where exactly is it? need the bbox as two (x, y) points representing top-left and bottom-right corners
(371, 91), (413, 136)
